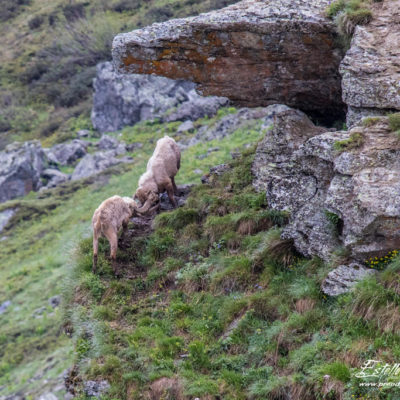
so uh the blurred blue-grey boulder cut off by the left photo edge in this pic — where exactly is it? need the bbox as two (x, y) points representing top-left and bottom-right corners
(0, 140), (46, 203)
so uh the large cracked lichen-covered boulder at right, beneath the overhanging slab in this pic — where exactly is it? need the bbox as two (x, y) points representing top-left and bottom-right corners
(253, 106), (400, 262)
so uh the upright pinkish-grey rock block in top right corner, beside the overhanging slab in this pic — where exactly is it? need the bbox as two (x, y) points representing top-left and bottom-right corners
(340, 0), (400, 127)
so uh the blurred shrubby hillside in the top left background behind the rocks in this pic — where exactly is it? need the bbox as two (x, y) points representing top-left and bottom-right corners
(0, 0), (235, 148)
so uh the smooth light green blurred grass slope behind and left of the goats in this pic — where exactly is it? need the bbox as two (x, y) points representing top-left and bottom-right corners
(0, 109), (266, 395)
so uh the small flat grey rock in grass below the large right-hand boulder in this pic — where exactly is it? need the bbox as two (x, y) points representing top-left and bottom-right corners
(321, 263), (376, 296)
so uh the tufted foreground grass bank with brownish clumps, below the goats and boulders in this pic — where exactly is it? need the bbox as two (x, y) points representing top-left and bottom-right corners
(66, 143), (400, 400)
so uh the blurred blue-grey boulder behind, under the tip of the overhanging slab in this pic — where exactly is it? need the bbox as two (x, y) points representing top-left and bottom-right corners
(92, 62), (227, 132)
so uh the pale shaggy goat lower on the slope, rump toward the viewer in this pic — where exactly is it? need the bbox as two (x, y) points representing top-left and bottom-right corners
(92, 196), (137, 273)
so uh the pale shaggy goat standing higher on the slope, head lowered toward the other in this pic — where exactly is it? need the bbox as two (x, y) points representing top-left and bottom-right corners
(135, 136), (181, 213)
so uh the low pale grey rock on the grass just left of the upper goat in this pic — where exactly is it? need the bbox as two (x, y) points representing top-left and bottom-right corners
(71, 150), (133, 181)
